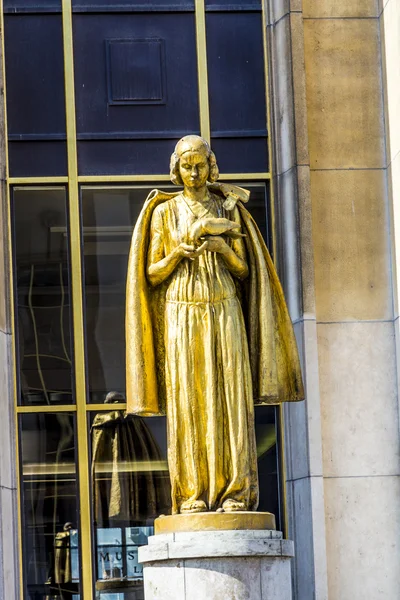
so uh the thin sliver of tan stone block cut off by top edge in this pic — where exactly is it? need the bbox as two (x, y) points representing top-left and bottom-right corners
(303, 0), (379, 19)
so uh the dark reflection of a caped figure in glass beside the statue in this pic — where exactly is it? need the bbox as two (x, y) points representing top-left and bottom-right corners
(92, 392), (169, 527)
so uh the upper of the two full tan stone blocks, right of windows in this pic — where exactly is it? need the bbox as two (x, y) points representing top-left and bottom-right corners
(304, 19), (385, 169)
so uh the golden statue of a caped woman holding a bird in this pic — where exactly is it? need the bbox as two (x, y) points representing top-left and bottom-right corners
(126, 135), (304, 514)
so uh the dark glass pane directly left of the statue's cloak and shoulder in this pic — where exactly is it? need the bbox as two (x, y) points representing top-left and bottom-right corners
(82, 183), (177, 403)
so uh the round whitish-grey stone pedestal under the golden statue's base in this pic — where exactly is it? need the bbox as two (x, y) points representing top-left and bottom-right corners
(139, 530), (294, 600)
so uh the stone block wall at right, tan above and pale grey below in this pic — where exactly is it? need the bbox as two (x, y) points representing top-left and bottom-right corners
(299, 0), (400, 600)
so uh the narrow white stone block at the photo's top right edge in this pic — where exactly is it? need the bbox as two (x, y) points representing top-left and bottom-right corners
(381, 0), (400, 162)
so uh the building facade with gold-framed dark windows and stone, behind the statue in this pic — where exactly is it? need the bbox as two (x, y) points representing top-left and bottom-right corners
(0, 0), (400, 600)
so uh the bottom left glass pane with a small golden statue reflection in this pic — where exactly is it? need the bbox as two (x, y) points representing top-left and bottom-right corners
(20, 413), (80, 600)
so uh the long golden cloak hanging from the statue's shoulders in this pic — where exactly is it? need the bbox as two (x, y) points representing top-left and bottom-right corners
(125, 184), (304, 416)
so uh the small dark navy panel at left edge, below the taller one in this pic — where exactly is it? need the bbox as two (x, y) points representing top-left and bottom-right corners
(8, 141), (67, 177)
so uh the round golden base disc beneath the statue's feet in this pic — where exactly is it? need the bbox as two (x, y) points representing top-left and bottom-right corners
(154, 511), (276, 535)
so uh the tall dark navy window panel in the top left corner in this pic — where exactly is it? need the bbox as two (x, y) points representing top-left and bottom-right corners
(5, 15), (65, 134)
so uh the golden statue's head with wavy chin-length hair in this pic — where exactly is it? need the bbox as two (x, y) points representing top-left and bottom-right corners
(170, 135), (219, 188)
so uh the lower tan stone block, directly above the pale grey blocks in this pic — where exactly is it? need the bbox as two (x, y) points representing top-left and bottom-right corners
(311, 170), (392, 321)
